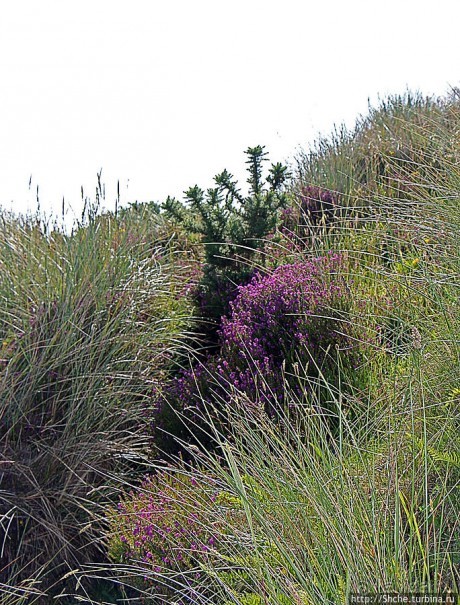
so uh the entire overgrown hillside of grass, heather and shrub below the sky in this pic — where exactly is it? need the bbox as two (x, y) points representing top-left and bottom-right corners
(0, 93), (460, 605)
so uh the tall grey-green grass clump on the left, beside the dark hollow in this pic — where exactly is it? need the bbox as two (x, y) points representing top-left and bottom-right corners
(0, 203), (191, 603)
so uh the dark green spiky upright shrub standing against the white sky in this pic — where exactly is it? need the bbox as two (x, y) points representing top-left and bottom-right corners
(163, 145), (288, 319)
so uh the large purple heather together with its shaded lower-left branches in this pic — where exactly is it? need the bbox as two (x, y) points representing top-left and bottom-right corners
(152, 255), (354, 450)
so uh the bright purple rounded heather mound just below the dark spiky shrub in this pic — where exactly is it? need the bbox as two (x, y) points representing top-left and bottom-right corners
(218, 255), (346, 407)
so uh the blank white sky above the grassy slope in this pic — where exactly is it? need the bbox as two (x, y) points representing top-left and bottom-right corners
(0, 0), (460, 222)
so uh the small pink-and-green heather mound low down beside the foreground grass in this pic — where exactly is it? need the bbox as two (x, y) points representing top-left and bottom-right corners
(109, 469), (239, 591)
